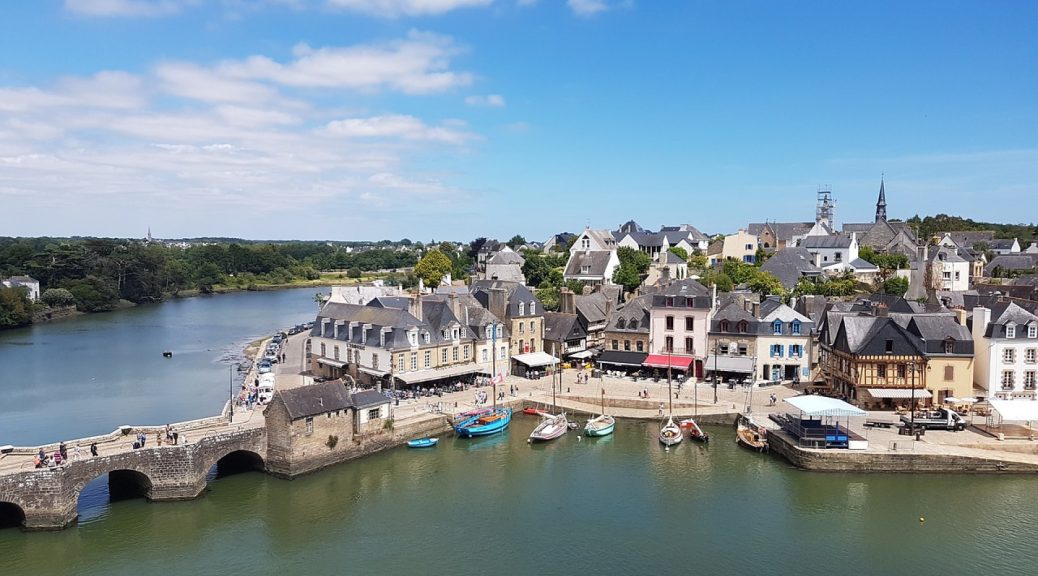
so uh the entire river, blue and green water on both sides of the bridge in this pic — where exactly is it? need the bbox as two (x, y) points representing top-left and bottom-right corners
(0, 291), (1038, 576)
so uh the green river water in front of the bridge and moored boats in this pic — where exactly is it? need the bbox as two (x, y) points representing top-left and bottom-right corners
(0, 416), (1038, 576)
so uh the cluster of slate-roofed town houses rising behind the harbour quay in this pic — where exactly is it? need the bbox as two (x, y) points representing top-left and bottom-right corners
(308, 182), (1038, 409)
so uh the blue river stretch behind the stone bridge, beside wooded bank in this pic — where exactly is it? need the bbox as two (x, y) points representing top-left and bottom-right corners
(0, 289), (327, 446)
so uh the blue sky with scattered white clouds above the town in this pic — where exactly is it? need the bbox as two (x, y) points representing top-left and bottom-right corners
(0, 0), (1038, 241)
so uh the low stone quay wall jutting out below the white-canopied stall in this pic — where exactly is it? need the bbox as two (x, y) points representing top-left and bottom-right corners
(768, 431), (1038, 474)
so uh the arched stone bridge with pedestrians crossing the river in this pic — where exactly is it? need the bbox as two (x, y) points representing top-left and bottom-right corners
(0, 426), (267, 529)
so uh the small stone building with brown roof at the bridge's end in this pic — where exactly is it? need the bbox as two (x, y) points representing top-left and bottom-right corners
(264, 382), (390, 477)
